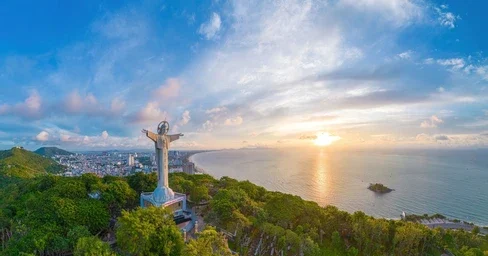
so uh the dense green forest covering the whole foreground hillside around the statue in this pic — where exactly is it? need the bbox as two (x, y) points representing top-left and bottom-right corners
(0, 159), (488, 256)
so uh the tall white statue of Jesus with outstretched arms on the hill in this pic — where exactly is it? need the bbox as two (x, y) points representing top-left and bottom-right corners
(142, 121), (183, 204)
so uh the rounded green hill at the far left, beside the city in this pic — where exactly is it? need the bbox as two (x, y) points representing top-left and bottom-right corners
(0, 148), (66, 179)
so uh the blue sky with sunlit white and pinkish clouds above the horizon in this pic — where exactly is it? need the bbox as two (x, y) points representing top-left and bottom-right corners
(0, 0), (488, 150)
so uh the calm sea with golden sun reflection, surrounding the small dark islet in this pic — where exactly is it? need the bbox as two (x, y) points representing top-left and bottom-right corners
(192, 149), (488, 226)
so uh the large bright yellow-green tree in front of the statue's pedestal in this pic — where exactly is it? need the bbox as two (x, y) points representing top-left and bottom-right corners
(116, 207), (184, 256)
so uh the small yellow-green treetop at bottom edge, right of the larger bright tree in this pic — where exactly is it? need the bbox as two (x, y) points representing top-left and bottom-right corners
(183, 227), (232, 256)
